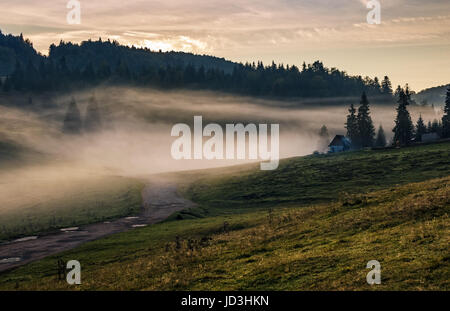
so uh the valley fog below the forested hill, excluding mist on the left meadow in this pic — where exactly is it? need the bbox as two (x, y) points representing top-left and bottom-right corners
(0, 88), (440, 175)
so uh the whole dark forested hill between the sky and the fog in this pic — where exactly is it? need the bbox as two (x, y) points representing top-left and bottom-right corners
(0, 32), (392, 102)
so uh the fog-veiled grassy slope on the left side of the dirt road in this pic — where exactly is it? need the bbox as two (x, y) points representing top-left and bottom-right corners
(0, 128), (144, 242)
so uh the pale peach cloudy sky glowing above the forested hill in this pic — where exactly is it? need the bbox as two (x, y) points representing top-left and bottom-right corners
(0, 0), (450, 91)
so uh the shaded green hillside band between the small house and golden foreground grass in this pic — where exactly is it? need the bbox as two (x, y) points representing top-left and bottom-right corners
(174, 143), (450, 217)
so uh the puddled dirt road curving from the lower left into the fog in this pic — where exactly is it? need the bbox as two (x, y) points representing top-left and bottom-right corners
(0, 182), (195, 272)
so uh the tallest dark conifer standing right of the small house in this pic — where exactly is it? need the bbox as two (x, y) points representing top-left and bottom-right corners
(392, 89), (414, 145)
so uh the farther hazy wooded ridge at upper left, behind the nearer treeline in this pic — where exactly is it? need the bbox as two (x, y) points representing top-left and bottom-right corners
(0, 30), (236, 76)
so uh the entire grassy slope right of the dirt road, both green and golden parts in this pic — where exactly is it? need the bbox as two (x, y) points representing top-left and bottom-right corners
(0, 143), (450, 290)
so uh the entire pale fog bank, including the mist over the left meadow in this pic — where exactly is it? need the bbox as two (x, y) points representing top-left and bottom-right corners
(0, 88), (440, 236)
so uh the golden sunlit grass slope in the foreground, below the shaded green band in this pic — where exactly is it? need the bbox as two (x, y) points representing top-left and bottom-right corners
(0, 177), (450, 290)
